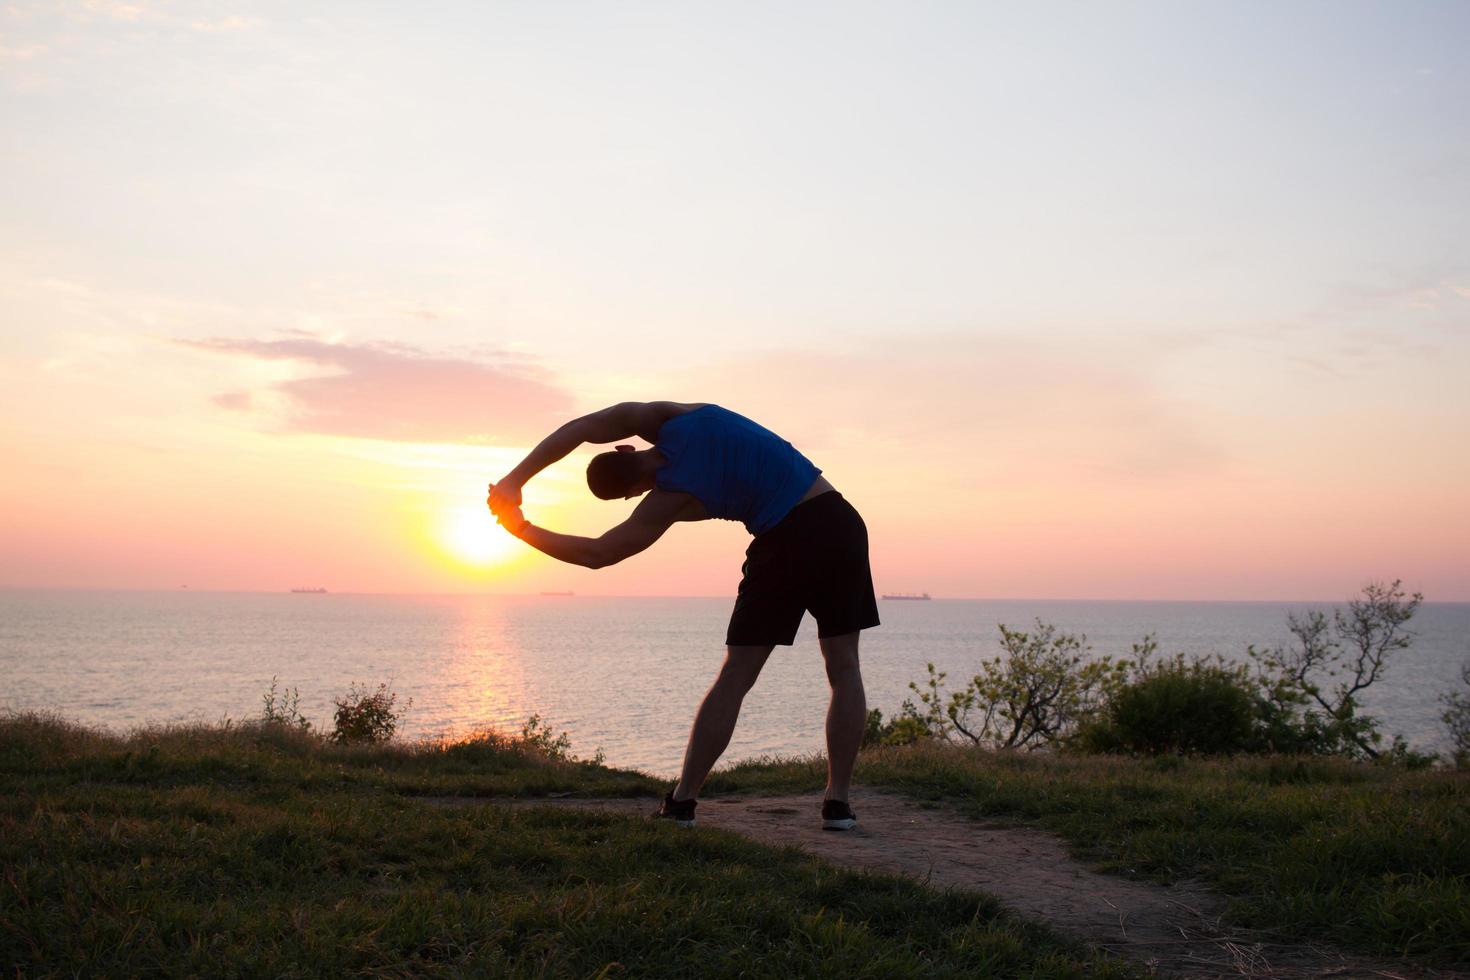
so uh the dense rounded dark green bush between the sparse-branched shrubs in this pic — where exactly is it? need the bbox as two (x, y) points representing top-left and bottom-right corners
(1078, 654), (1257, 755)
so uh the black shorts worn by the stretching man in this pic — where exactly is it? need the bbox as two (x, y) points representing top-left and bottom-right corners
(725, 491), (878, 646)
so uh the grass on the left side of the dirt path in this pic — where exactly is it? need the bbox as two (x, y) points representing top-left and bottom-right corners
(0, 714), (1138, 977)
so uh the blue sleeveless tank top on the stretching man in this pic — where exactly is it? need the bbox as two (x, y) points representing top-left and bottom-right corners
(654, 406), (822, 535)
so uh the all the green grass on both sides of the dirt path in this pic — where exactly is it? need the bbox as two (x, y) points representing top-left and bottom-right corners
(0, 714), (1470, 977)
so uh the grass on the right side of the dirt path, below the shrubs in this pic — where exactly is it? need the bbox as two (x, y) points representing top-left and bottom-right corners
(707, 745), (1470, 967)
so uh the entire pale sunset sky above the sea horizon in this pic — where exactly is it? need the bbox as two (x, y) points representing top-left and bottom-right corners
(0, 0), (1470, 601)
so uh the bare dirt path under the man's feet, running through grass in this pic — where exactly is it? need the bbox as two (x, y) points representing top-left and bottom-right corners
(464, 790), (1463, 977)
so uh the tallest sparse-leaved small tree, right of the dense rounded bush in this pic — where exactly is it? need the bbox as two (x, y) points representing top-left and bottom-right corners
(1247, 579), (1424, 758)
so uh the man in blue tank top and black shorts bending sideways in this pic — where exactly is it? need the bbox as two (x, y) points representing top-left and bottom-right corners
(488, 401), (878, 830)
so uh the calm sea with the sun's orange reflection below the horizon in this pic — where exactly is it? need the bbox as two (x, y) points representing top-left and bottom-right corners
(0, 589), (1470, 776)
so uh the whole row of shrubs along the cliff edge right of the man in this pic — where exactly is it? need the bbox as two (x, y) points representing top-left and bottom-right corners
(863, 580), (1428, 768)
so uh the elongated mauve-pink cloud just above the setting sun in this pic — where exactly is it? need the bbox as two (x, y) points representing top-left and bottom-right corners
(178, 335), (572, 445)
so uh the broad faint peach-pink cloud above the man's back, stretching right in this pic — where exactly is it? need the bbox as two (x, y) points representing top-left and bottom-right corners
(667, 335), (1229, 479)
